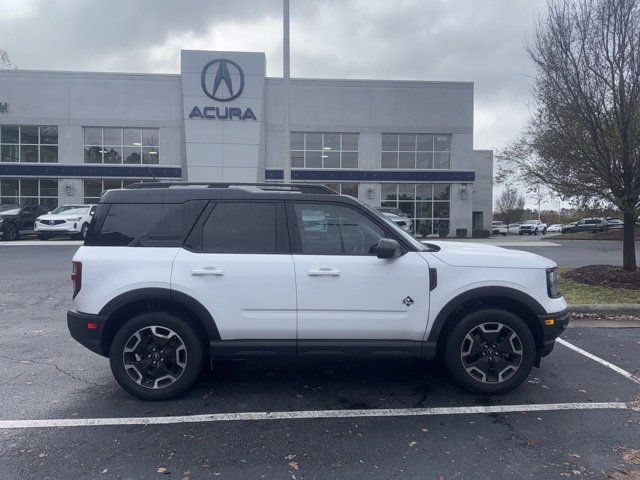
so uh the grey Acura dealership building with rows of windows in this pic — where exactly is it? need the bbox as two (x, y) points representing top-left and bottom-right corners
(0, 50), (493, 235)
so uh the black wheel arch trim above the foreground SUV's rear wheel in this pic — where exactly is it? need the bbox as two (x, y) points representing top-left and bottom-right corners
(99, 288), (220, 341)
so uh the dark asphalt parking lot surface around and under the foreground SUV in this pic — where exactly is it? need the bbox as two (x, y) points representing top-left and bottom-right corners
(0, 245), (640, 479)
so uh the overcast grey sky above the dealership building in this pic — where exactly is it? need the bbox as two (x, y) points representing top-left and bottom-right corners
(0, 0), (545, 203)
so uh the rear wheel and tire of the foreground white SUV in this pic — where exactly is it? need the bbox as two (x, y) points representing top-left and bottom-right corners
(109, 312), (204, 400)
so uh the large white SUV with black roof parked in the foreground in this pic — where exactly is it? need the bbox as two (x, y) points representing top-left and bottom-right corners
(67, 183), (569, 400)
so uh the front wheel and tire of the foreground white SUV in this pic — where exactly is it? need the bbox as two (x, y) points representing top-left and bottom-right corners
(444, 308), (537, 395)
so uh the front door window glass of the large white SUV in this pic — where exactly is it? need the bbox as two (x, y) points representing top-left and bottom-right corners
(295, 203), (385, 255)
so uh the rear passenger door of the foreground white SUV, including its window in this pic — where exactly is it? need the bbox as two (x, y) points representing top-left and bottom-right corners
(171, 201), (296, 346)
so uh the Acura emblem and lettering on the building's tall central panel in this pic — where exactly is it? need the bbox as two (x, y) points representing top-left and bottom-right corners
(189, 58), (256, 120)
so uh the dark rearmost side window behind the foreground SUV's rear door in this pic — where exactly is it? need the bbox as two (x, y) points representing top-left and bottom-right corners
(85, 200), (207, 247)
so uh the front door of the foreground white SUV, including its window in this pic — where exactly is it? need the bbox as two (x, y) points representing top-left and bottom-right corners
(287, 202), (429, 354)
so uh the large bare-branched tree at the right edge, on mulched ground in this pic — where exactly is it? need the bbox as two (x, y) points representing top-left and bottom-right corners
(501, 0), (640, 270)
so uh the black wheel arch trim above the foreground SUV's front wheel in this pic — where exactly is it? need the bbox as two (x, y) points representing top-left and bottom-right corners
(427, 287), (546, 344)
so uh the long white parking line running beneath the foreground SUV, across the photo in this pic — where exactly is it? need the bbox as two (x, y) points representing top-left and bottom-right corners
(0, 402), (630, 429)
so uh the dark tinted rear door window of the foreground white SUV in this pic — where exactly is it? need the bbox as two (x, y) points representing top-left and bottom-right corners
(195, 202), (288, 253)
